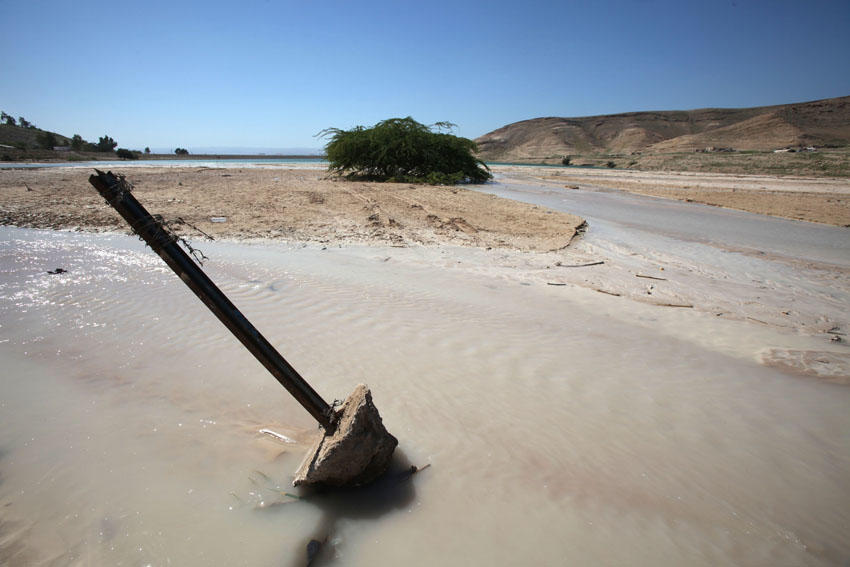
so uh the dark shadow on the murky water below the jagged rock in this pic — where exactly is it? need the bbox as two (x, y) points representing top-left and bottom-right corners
(268, 449), (424, 567)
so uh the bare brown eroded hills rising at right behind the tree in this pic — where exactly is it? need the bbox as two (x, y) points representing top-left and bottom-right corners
(475, 96), (850, 161)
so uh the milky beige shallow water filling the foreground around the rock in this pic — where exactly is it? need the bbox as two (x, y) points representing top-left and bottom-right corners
(0, 227), (850, 566)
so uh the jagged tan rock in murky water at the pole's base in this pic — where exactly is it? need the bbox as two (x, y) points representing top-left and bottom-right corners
(292, 384), (398, 486)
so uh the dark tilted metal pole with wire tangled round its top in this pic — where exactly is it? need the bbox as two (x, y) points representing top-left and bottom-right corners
(89, 169), (335, 433)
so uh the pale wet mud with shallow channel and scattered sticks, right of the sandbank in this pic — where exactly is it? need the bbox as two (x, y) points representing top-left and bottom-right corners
(478, 173), (850, 356)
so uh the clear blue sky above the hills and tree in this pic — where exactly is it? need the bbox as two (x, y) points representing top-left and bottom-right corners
(0, 0), (850, 150)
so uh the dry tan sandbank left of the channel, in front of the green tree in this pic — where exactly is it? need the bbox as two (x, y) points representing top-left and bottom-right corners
(0, 167), (584, 251)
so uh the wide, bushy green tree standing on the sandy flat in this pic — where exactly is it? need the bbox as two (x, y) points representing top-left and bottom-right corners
(318, 116), (492, 185)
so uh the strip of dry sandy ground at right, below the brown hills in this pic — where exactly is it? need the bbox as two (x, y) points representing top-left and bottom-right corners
(495, 167), (850, 226)
